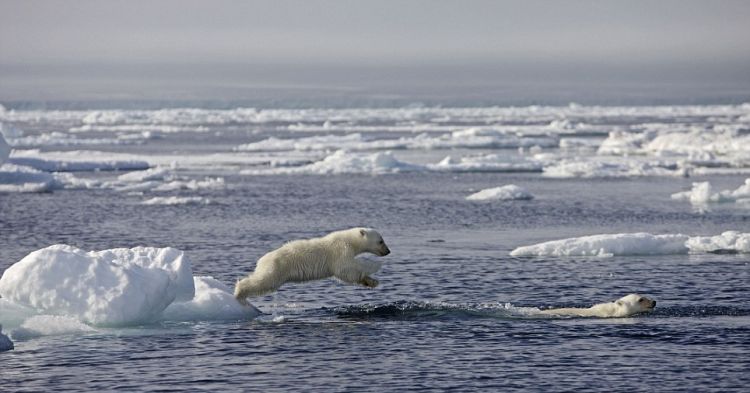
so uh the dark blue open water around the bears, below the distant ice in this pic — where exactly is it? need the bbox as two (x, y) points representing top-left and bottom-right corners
(0, 173), (750, 392)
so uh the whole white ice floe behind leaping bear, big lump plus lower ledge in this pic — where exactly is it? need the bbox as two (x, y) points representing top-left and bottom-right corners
(0, 245), (258, 334)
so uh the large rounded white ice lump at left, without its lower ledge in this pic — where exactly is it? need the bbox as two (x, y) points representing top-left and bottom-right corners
(0, 245), (195, 325)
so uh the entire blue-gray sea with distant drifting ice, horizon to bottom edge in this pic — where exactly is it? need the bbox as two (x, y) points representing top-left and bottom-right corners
(0, 104), (750, 392)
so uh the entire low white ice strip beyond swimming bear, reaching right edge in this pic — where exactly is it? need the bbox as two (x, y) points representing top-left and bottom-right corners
(510, 231), (750, 257)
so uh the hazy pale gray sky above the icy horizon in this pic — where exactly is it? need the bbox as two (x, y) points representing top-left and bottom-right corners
(0, 0), (750, 105)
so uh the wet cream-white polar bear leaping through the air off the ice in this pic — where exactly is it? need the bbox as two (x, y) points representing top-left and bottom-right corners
(234, 228), (391, 305)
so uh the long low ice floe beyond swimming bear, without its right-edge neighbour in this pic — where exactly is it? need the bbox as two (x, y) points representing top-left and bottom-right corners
(510, 233), (688, 257)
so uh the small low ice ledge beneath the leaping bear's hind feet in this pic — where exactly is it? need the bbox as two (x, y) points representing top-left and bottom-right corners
(163, 276), (261, 321)
